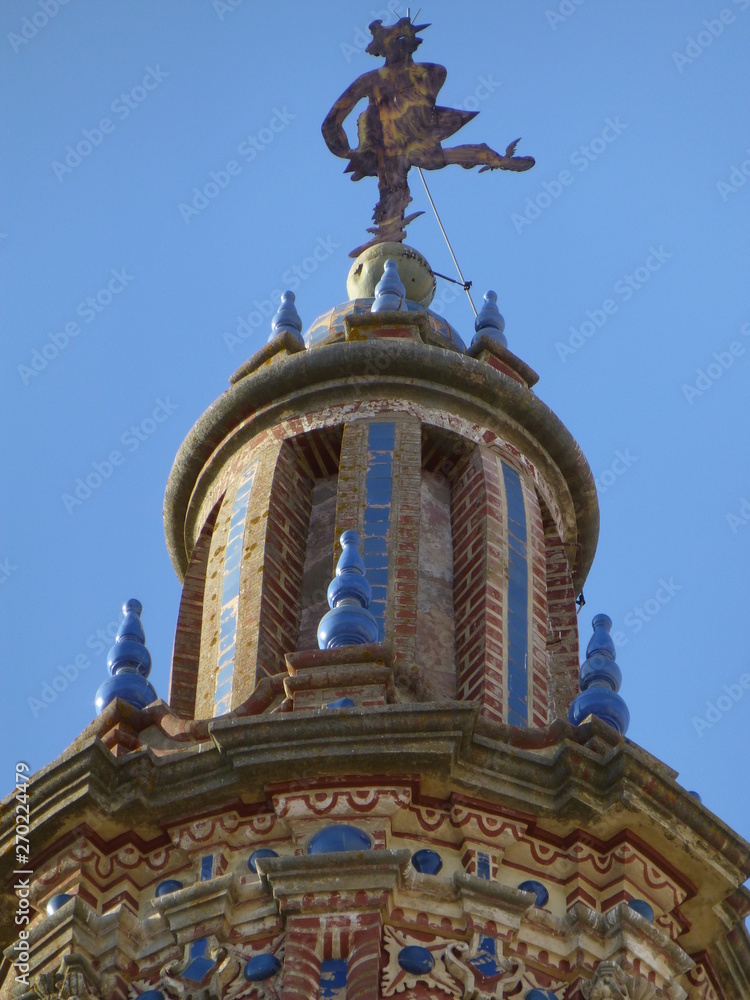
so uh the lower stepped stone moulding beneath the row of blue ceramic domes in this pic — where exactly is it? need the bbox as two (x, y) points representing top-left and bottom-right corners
(4, 880), (695, 995)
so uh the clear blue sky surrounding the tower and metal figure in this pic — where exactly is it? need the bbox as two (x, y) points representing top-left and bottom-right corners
(0, 0), (750, 868)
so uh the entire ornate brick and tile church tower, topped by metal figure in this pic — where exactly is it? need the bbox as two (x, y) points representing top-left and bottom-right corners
(0, 13), (750, 1000)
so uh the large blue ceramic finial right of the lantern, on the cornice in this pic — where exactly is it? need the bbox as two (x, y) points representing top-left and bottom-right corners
(568, 615), (630, 736)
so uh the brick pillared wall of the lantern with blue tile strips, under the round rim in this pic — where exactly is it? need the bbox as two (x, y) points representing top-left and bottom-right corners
(169, 401), (578, 727)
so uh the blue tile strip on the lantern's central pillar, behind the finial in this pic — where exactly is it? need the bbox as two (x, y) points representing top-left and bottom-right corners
(362, 423), (396, 639)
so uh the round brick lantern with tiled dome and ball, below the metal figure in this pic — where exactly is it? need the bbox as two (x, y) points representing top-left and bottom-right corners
(165, 243), (598, 727)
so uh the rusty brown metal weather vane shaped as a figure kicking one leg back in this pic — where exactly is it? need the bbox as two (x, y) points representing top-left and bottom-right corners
(322, 15), (534, 257)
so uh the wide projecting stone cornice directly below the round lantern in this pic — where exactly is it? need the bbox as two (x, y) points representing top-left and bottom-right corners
(0, 702), (750, 952)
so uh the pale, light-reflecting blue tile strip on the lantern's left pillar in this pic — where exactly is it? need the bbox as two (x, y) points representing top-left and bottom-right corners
(214, 460), (258, 718)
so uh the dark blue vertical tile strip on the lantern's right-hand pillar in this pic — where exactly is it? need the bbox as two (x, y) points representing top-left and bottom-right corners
(502, 462), (529, 726)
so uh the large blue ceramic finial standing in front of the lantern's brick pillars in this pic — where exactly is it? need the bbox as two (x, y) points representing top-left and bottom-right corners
(318, 531), (380, 649)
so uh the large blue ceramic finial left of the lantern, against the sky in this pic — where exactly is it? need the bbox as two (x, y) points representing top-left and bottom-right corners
(95, 598), (157, 715)
